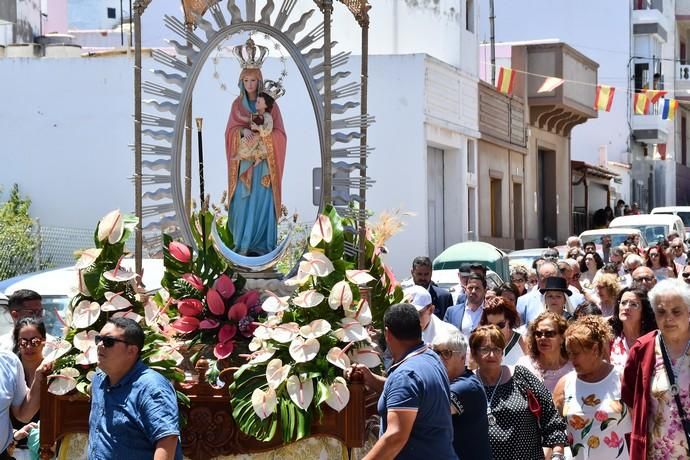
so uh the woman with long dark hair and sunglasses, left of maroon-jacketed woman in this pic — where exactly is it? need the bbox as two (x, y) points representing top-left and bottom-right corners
(609, 288), (657, 372)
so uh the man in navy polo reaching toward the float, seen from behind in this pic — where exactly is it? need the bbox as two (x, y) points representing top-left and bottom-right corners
(353, 304), (457, 460)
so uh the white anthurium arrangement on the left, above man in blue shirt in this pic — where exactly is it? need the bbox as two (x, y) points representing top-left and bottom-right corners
(44, 210), (186, 402)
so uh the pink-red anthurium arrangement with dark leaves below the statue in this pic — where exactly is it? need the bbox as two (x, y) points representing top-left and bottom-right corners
(159, 211), (266, 382)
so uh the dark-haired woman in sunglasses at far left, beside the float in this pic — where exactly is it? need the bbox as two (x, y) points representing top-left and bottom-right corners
(11, 316), (46, 458)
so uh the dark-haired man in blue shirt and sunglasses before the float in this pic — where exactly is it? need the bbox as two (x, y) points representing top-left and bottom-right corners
(88, 318), (182, 460)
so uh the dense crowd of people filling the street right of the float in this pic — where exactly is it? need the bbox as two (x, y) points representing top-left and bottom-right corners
(368, 234), (690, 460)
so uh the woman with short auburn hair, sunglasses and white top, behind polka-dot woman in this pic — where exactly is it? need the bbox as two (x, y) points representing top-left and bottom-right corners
(479, 297), (527, 366)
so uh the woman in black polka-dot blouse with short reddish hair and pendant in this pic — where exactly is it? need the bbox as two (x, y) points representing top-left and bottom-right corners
(470, 325), (565, 460)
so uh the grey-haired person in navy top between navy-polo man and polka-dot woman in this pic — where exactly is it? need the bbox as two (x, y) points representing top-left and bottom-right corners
(432, 325), (491, 460)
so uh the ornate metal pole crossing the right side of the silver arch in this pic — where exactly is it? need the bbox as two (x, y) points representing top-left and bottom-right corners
(321, 0), (333, 204)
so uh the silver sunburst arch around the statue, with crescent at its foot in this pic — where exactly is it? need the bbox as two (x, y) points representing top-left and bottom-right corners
(135, 0), (373, 272)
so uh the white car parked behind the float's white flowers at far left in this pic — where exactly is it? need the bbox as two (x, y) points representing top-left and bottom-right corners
(0, 259), (163, 337)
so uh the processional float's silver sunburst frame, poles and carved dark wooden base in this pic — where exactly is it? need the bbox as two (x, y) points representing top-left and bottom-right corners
(40, 0), (376, 459)
